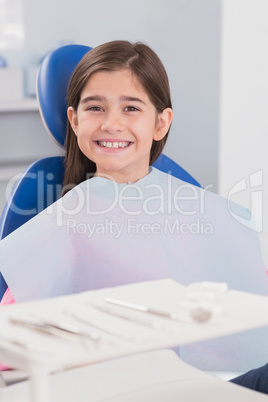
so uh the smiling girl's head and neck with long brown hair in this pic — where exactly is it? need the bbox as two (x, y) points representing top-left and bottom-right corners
(64, 41), (172, 192)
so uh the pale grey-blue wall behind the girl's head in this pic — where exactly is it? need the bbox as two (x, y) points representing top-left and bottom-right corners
(0, 0), (221, 191)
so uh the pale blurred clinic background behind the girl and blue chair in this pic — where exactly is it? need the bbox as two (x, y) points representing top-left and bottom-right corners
(0, 0), (268, 267)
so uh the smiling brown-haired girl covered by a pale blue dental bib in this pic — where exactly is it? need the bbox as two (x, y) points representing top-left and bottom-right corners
(0, 41), (268, 390)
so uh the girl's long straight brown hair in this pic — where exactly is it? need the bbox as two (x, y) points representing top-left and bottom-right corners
(63, 41), (172, 194)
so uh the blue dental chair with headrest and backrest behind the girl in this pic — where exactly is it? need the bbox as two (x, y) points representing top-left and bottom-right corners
(0, 45), (201, 300)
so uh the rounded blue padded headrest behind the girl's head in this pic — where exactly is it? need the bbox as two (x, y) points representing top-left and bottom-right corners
(37, 45), (92, 146)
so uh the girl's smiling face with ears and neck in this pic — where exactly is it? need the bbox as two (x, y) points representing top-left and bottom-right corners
(68, 70), (172, 183)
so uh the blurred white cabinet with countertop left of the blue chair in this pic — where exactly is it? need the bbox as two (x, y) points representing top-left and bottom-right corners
(0, 99), (63, 211)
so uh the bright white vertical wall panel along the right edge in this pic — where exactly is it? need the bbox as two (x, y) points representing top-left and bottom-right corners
(219, 0), (268, 267)
